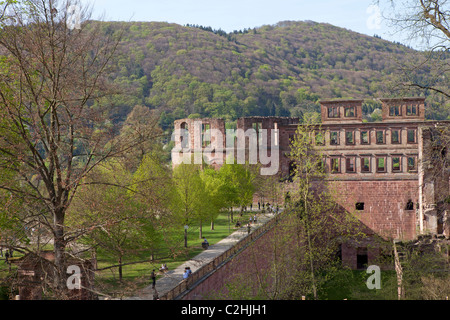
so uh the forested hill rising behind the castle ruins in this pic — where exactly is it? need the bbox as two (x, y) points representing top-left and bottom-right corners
(103, 21), (447, 127)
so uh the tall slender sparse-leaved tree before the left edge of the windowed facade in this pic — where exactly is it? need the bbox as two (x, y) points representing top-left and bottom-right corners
(286, 119), (363, 299)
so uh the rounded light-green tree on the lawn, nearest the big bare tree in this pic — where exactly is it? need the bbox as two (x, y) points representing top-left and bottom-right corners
(67, 161), (159, 281)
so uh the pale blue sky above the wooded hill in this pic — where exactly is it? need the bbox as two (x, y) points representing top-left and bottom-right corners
(79, 0), (405, 43)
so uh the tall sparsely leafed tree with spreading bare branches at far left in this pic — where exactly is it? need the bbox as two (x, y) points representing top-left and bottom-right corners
(0, 0), (139, 297)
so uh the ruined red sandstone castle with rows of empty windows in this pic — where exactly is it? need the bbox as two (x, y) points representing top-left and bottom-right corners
(172, 98), (450, 268)
